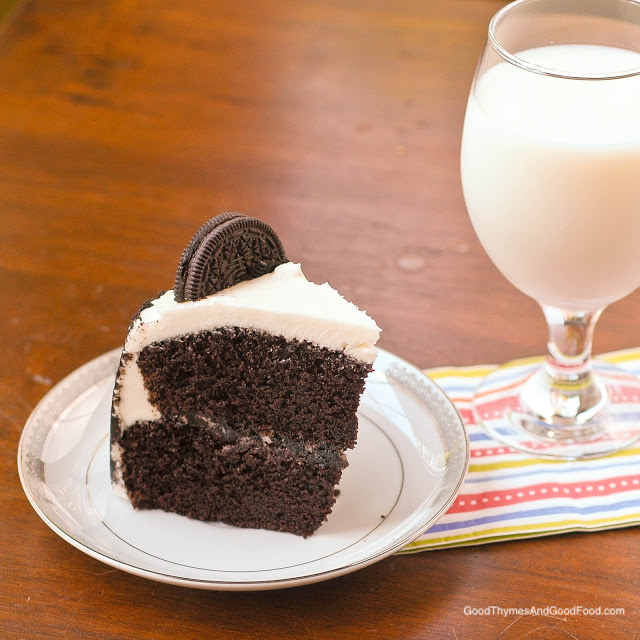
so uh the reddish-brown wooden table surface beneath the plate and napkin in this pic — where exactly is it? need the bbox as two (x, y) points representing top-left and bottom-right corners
(0, 0), (640, 640)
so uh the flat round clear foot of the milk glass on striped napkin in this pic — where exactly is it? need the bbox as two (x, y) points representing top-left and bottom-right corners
(473, 359), (640, 460)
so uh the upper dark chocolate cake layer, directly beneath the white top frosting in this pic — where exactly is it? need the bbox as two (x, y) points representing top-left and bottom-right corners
(138, 327), (371, 449)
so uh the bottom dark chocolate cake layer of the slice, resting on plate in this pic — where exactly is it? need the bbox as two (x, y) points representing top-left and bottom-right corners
(121, 414), (347, 537)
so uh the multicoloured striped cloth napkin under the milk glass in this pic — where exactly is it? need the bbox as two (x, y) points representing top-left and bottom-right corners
(401, 349), (640, 553)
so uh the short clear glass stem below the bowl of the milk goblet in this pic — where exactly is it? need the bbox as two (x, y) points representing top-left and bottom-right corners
(539, 305), (606, 426)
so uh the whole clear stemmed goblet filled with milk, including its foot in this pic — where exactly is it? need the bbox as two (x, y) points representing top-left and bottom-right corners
(461, 0), (640, 459)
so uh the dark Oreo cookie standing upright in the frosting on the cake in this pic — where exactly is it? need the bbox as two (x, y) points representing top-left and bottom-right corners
(173, 213), (287, 302)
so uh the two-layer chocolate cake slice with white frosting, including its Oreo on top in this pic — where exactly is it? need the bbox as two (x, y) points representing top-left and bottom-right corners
(111, 214), (380, 537)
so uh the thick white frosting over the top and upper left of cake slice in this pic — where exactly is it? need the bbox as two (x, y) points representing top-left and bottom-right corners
(117, 262), (380, 427)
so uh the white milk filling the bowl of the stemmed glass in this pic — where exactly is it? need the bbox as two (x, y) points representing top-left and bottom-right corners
(461, 45), (640, 310)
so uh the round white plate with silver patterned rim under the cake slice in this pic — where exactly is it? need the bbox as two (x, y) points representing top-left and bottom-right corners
(18, 349), (469, 590)
